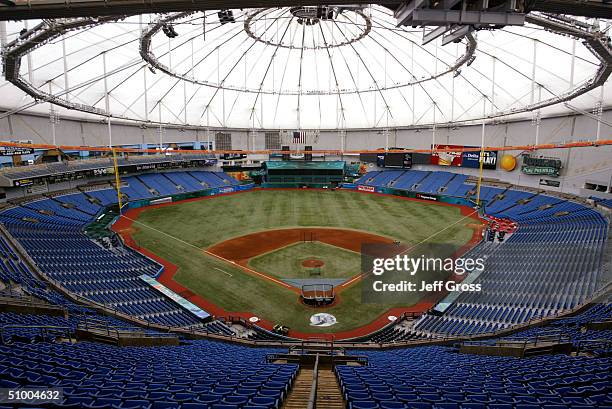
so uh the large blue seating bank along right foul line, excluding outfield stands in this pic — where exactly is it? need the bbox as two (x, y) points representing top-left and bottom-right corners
(413, 209), (608, 336)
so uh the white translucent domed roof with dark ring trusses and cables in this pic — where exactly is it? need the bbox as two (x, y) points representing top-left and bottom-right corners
(0, 5), (612, 129)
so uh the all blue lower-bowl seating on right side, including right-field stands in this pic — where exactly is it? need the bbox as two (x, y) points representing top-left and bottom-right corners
(356, 170), (608, 342)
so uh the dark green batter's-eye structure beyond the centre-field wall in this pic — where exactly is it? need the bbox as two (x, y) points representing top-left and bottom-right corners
(263, 161), (346, 187)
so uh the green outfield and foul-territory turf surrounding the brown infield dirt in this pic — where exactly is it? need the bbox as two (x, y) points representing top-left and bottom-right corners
(133, 190), (474, 332)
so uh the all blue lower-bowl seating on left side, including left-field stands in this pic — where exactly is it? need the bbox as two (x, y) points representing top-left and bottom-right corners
(0, 172), (240, 328)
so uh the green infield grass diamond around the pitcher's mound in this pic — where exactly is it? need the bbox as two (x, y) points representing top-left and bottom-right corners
(249, 242), (361, 279)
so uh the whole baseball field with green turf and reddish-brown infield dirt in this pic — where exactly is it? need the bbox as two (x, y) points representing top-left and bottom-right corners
(130, 189), (478, 333)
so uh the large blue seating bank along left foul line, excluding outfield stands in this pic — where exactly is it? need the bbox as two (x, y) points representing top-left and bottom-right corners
(0, 222), (206, 327)
